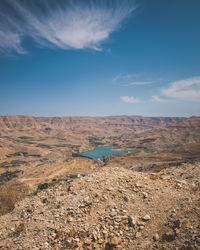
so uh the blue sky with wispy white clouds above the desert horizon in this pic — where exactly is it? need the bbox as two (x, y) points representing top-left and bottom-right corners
(0, 0), (200, 117)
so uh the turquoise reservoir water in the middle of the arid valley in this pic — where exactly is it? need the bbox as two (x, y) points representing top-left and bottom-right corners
(79, 146), (136, 159)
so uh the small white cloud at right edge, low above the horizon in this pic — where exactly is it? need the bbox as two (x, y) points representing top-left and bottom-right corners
(161, 76), (200, 102)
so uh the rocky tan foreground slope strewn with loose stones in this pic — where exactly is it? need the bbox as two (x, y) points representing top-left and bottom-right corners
(0, 163), (200, 249)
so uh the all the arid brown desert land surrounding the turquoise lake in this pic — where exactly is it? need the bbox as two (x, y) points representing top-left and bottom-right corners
(0, 116), (200, 249)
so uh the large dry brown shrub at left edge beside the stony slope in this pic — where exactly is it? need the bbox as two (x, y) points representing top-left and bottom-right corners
(0, 182), (28, 216)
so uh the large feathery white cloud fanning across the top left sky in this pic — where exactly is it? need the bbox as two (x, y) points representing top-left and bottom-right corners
(0, 0), (136, 53)
